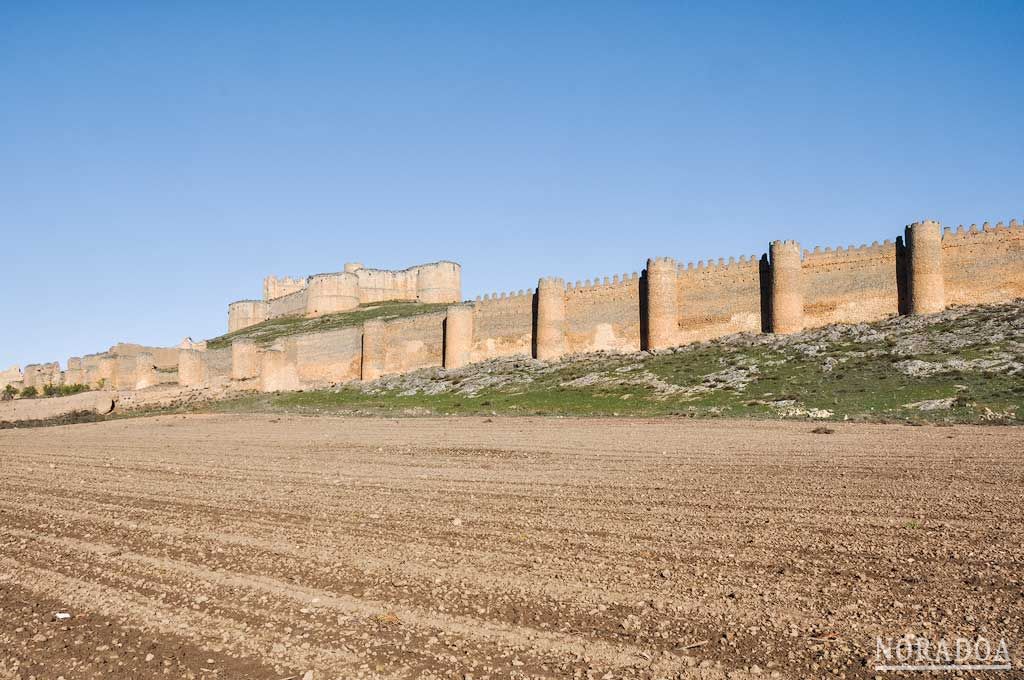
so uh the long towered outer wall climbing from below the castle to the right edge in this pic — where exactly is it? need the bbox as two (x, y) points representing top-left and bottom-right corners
(167, 215), (1024, 391)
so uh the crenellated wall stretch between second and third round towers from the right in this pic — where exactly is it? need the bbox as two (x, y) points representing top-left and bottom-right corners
(676, 255), (762, 344)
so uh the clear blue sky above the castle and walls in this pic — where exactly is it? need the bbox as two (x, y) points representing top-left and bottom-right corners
(0, 0), (1024, 368)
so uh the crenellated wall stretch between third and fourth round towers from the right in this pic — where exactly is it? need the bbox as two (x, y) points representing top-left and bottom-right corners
(565, 271), (640, 354)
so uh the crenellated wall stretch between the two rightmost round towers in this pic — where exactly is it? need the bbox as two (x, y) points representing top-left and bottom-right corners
(802, 241), (899, 328)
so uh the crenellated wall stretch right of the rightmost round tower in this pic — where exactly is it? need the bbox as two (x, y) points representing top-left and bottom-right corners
(942, 220), (1024, 305)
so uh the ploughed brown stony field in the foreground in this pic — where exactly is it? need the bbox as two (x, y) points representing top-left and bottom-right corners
(0, 415), (1024, 680)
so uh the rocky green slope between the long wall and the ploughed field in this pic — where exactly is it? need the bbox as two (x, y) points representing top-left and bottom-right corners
(201, 302), (1024, 423)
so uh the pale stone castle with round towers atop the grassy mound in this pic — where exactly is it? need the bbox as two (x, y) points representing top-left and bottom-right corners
(227, 261), (462, 333)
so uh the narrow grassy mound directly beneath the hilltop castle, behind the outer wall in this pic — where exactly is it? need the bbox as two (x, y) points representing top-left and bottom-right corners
(207, 302), (447, 349)
